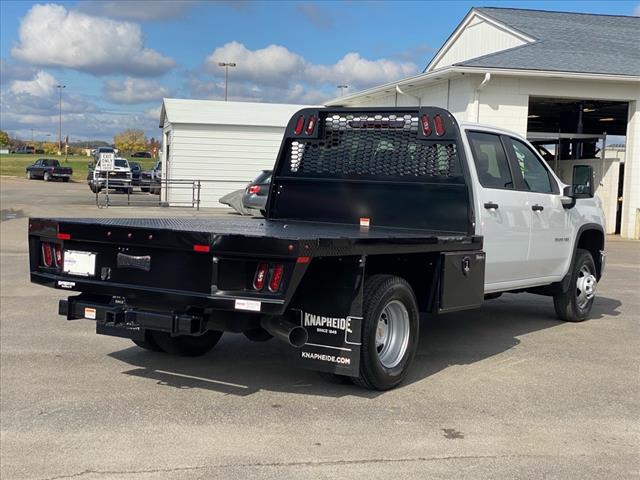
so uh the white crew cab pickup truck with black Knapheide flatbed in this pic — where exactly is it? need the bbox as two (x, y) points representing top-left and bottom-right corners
(29, 107), (605, 390)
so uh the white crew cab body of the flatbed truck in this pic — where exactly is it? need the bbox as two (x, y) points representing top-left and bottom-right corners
(460, 123), (605, 300)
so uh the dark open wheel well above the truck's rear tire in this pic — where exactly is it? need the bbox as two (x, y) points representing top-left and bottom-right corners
(366, 253), (440, 312)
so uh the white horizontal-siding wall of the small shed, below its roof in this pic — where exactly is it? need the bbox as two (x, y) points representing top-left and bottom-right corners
(163, 124), (284, 207)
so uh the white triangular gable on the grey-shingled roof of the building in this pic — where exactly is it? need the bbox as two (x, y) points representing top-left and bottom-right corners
(429, 17), (525, 71)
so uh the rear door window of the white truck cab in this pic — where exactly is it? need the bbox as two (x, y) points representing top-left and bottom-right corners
(467, 132), (513, 188)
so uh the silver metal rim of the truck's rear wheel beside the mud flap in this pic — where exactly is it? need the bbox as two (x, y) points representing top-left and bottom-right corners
(376, 300), (411, 368)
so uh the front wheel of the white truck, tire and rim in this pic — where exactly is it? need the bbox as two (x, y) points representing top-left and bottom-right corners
(553, 249), (598, 322)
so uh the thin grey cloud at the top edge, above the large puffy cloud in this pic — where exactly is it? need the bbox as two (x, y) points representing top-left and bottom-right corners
(78, 0), (198, 21)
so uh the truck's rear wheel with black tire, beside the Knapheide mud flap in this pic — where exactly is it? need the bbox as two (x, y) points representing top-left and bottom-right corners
(352, 275), (420, 390)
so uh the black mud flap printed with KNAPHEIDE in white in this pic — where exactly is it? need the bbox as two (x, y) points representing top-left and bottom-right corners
(288, 257), (364, 377)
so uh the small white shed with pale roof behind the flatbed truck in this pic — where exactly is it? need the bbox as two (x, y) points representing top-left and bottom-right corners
(160, 98), (305, 207)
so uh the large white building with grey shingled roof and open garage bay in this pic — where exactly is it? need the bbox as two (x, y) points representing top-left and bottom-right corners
(328, 8), (640, 238)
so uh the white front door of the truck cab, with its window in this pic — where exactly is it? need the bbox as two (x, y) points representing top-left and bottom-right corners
(505, 137), (572, 279)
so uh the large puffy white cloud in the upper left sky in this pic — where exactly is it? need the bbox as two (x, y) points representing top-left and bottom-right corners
(11, 4), (175, 76)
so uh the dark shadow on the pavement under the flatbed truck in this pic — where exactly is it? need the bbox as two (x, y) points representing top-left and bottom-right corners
(110, 294), (621, 400)
